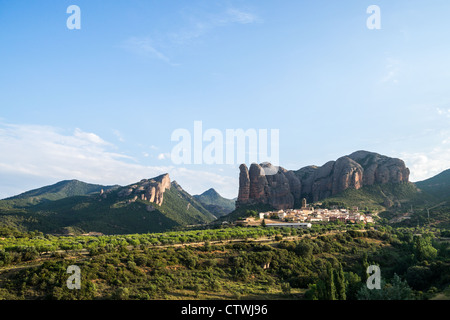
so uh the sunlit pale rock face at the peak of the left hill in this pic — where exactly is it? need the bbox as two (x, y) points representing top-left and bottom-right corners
(117, 173), (170, 205)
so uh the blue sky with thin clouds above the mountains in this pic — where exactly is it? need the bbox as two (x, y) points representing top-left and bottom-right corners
(0, 0), (450, 198)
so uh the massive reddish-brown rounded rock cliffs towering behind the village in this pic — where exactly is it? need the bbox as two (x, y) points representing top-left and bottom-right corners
(236, 151), (409, 209)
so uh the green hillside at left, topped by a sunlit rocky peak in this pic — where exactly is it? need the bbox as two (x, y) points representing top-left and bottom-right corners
(0, 175), (215, 234)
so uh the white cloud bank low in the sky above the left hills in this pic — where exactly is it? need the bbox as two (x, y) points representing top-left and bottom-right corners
(0, 122), (238, 198)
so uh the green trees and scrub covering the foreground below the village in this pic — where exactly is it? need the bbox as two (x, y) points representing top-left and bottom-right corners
(0, 225), (450, 300)
